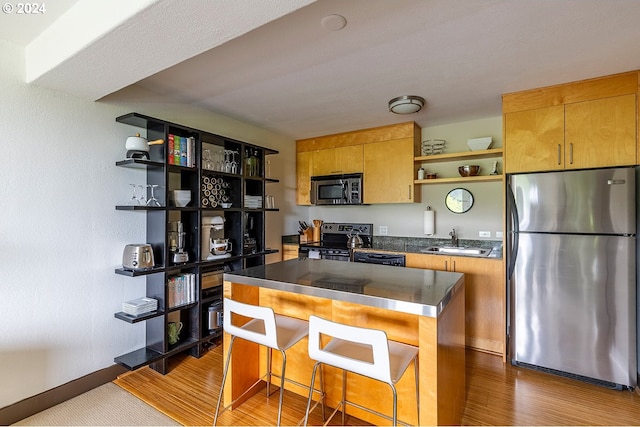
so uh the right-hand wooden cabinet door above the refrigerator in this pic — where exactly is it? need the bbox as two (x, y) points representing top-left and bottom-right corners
(564, 95), (637, 169)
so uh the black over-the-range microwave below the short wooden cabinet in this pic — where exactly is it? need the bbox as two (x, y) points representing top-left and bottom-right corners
(311, 173), (362, 205)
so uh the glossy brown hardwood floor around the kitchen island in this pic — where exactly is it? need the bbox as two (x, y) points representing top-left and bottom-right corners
(115, 346), (640, 426)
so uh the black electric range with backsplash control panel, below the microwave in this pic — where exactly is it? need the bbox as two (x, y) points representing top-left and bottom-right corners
(298, 222), (373, 261)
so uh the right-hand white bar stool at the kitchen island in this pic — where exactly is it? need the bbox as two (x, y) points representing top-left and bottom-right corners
(304, 316), (420, 426)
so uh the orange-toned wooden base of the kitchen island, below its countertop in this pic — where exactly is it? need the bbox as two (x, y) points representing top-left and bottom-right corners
(224, 279), (465, 425)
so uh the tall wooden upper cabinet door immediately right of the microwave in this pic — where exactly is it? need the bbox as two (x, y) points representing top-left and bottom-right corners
(363, 138), (418, 204)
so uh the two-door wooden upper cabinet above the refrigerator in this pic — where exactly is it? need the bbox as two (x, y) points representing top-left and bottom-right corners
(503, 72), (638, 173)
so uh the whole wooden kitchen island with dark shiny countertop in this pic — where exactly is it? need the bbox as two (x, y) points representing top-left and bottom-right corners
(224, 259), (465, 425)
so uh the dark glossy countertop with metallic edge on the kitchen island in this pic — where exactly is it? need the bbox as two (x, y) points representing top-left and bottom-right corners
(224, 258), (464, 317)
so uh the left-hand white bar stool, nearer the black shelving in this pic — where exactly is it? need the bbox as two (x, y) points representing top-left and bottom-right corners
(213, 298), (324, 426)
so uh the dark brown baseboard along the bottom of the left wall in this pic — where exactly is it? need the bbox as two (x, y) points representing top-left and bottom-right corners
(0, 365), (128, 425)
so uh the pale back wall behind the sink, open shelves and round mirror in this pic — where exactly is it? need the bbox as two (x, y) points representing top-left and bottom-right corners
(300, 117), (504, 240)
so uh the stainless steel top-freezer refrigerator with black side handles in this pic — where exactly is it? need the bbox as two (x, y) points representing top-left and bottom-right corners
(506, 168), (638, 388)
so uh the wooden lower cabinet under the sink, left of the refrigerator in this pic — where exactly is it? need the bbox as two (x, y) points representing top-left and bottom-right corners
(406, 253), (506, 357)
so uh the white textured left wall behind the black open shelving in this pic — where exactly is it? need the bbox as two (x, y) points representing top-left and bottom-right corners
(0, 41), (295, 408)
